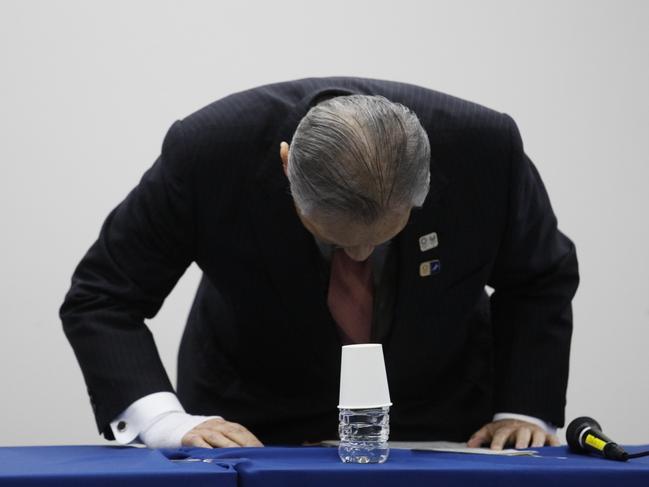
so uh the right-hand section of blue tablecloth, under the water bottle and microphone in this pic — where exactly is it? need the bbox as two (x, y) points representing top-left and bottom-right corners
(177, 446), (649, 487)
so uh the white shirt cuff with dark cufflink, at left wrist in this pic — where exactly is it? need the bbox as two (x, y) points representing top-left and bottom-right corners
(110, 392), (185, 445)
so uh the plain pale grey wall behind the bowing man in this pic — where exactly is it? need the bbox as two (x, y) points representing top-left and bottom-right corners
(0, 0), (649, 445)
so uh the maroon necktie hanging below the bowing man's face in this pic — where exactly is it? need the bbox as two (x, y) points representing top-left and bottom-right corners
(327, 249), (373, 345)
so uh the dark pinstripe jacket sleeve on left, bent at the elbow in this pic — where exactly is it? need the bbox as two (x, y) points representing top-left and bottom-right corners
(60, 122), (195, 439)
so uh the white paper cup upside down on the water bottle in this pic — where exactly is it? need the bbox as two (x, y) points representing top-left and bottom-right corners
(338, 343), (392, 409)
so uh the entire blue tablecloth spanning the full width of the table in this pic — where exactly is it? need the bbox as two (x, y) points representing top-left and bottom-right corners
(0, 446), (649, 487)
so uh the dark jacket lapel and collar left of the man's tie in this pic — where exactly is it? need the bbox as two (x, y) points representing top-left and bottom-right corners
(252, 86), (362, 374)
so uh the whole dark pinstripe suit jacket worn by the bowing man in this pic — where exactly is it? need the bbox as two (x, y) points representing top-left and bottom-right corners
(61, 77), (578, 443)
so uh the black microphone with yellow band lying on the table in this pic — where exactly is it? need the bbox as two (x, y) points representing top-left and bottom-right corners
(566, 416), (629, 462)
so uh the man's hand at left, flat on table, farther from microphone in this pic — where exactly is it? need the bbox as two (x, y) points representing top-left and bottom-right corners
(182, 418), (264, 448)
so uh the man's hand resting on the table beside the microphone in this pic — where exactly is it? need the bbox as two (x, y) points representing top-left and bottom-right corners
(467, 419), (559, 450)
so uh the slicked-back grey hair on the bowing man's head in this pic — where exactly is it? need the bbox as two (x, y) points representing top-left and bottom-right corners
(288, 95), (430, 224)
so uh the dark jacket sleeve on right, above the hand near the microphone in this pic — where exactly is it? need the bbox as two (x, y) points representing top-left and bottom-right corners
(490, 116), (579, 426)
